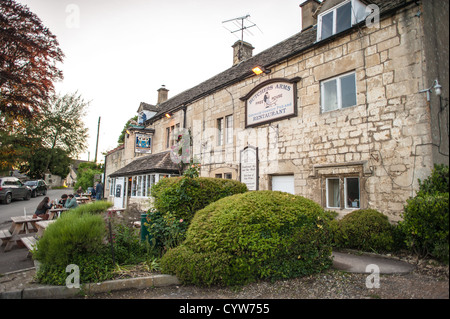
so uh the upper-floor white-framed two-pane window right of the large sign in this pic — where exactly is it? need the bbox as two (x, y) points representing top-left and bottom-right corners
(320, 72), (356, 112)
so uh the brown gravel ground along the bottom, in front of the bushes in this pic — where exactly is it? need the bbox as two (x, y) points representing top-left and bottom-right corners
(0, 252), (449, 299)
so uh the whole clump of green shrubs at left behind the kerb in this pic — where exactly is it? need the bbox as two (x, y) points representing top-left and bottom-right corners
(33, 201), (151, 285)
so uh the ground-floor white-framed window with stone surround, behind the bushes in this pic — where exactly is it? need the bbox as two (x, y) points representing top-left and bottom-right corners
(326, 176), (361, 209)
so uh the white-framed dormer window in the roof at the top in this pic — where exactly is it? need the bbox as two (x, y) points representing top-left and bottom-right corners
(317, 0), (366, 41)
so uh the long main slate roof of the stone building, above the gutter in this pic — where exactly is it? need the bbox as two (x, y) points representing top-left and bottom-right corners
(146, 0), (414, 124)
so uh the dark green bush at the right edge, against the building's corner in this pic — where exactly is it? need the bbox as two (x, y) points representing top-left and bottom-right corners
(399, 165), (449, 263)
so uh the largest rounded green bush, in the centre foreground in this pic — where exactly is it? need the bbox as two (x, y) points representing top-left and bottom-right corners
(160, 191), (332, 286)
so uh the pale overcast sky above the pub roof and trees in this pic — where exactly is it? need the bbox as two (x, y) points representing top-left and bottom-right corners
(16, 0), (303, 161)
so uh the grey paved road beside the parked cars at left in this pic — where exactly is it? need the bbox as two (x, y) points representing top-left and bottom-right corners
(0, 188), (73, 229)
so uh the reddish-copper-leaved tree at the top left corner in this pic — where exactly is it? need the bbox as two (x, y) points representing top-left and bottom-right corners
(0, 0), (64, 118)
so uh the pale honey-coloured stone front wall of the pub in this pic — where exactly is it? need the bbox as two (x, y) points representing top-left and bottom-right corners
(148, 6), (432, 220)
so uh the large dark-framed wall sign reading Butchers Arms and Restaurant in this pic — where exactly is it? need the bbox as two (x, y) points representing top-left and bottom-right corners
(241, 77), (300, 128)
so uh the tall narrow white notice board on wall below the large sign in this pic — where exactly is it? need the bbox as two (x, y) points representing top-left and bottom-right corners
(240, 146), (259, 191)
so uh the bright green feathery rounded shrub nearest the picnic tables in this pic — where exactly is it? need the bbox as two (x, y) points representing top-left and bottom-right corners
(34, 212), (106, 266)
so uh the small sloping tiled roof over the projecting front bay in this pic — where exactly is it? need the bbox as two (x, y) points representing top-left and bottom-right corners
(109, 151), (179, 177)
